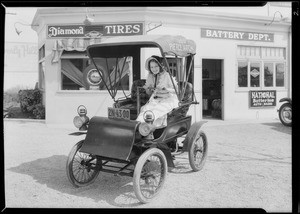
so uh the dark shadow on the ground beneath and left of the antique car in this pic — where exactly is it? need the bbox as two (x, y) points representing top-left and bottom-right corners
(8, 155), (141, 207)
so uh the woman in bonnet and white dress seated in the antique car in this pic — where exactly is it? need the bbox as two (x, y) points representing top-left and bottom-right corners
(136, 56), (179, 127)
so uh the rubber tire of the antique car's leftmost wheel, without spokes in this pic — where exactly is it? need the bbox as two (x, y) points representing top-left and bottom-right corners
(66, 140), (100, 187)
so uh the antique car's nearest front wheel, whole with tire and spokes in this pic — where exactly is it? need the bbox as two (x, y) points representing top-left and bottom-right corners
(133, 148), (167, 203)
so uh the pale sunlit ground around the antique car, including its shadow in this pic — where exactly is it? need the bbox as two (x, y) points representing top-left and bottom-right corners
(4, 120), (292, 212)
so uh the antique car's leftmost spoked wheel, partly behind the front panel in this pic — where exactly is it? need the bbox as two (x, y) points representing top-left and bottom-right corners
(66, 140), (101, 187)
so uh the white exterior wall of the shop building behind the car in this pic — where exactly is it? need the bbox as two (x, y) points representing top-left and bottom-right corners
(31, 5), (290, 125)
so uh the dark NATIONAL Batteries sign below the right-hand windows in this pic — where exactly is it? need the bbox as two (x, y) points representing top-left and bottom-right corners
(249, 90), (276, 107)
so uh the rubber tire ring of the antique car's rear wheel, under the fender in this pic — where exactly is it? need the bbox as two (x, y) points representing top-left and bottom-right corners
(188, 129), (208, 172)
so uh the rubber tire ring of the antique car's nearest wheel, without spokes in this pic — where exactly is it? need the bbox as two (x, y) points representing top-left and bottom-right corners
(133, 148), (168, 203)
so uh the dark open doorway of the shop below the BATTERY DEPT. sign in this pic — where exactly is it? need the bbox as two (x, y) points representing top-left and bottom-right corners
(202, 59), (223, 119)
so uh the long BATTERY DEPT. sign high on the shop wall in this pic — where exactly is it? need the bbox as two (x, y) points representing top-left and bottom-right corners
(201, 28), (274, 42)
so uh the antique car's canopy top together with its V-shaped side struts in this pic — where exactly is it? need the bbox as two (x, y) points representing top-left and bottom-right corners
(87, 35), (196, 101)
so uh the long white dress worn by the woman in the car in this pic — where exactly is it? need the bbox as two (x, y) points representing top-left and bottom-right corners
(136, 71), (178, 127)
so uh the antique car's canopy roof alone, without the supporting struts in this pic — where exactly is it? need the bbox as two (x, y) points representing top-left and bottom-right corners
(87, 35), (196, 58)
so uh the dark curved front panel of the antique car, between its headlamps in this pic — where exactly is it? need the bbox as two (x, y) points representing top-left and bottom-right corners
(80, 116), (139, 161)
